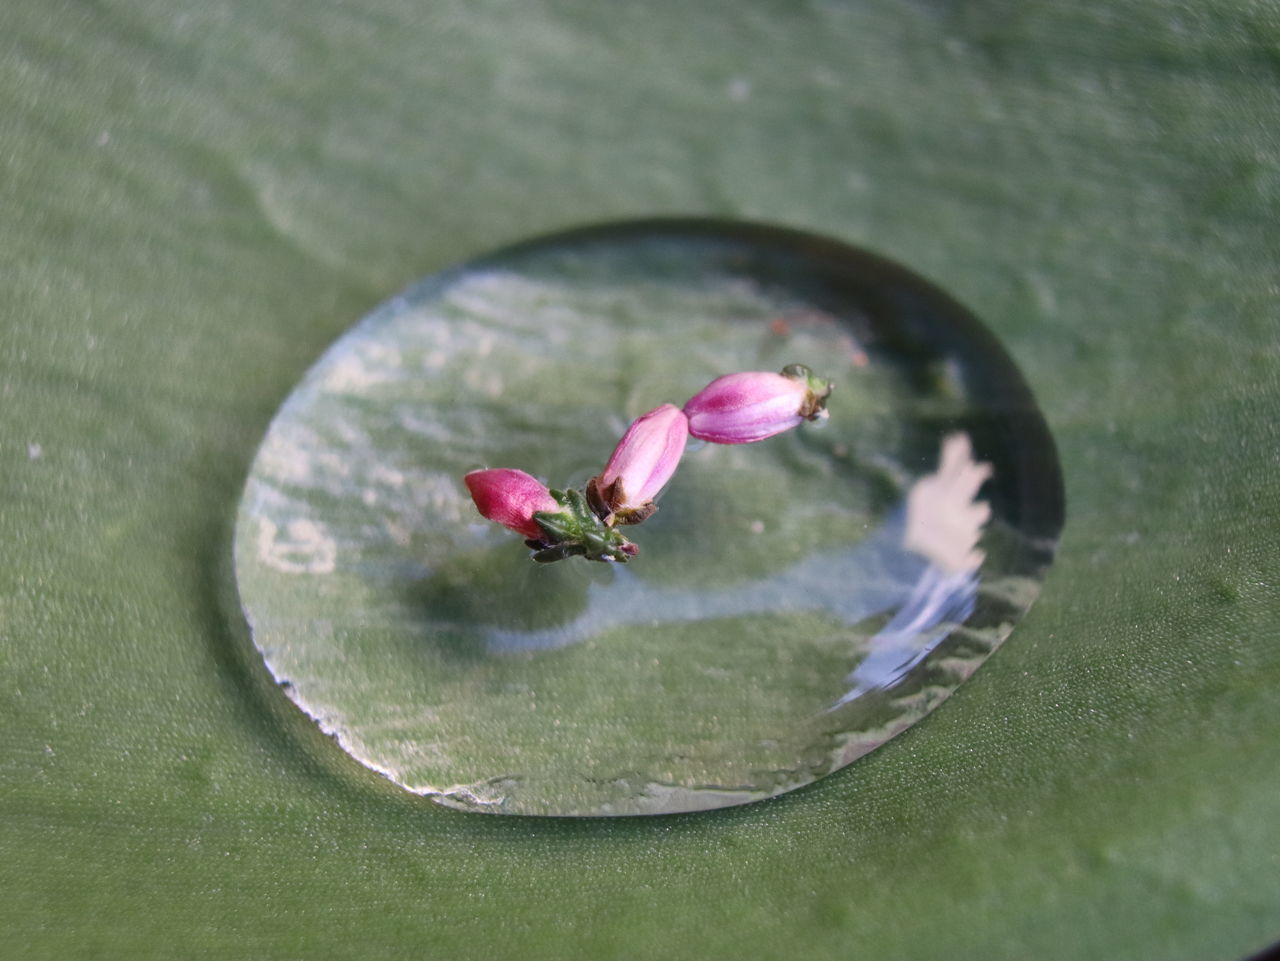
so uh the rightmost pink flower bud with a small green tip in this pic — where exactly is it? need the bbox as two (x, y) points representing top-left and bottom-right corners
(685, 363), (831, 444)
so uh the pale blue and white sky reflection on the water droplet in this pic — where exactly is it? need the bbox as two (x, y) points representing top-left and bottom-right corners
(486, 434), (991, 708)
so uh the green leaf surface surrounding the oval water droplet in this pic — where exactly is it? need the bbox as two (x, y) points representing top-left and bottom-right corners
(0, 0), (1280, 961)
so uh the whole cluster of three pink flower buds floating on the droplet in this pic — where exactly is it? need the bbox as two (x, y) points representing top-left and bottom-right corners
(463, 365), (832, 562)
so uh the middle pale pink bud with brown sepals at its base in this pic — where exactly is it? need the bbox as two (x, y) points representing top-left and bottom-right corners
(588, 404), (689, 523)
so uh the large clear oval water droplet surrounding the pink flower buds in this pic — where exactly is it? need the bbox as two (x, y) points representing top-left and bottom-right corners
(236, 221), (1062, 815)
